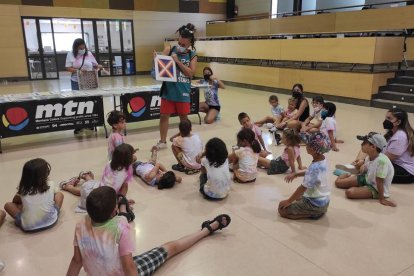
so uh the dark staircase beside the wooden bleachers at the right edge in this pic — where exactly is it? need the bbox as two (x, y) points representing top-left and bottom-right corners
(371, 68), (414, 113)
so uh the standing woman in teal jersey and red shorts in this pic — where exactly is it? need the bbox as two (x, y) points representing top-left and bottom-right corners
(154, 23), (197, 149)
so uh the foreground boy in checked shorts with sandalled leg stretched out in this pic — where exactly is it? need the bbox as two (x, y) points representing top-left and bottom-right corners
(66, 187), (231, 276)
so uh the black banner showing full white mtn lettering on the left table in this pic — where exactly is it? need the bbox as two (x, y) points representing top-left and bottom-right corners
(0, 96), (104, 138)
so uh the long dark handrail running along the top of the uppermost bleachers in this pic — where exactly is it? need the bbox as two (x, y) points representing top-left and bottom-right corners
(206, 0), (414, 24)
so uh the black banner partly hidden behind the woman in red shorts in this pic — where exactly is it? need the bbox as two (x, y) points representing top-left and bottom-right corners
(121, 88), (200, 123)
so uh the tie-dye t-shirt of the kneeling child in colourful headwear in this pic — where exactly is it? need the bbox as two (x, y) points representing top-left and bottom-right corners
(302, 159), (331, 207)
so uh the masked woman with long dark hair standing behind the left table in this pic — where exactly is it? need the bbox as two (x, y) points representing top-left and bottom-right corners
(65, 38), (102, 134)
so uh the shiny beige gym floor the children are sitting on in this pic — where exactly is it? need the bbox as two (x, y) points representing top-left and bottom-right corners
(0, 76), (414, 276)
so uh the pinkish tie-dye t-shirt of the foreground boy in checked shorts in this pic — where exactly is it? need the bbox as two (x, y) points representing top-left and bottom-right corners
(73, 215), (135, 276)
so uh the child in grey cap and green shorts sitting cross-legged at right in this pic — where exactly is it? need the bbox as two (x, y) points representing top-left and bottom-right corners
(335, 132), (396, 207)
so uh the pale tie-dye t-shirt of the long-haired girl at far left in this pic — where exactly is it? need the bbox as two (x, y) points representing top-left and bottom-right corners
(20, 181), (58, 231)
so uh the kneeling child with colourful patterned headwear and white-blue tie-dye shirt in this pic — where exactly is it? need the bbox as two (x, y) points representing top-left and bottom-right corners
(278, 132), (331, 219)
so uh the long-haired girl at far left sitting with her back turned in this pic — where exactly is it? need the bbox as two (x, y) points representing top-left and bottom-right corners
(4, 158), (63, 232)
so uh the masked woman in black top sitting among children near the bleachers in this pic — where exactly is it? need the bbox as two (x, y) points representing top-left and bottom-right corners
(277, 83), (309, 130)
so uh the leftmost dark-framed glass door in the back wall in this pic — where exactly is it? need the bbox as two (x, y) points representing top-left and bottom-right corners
(22, 18), (59, 80)
